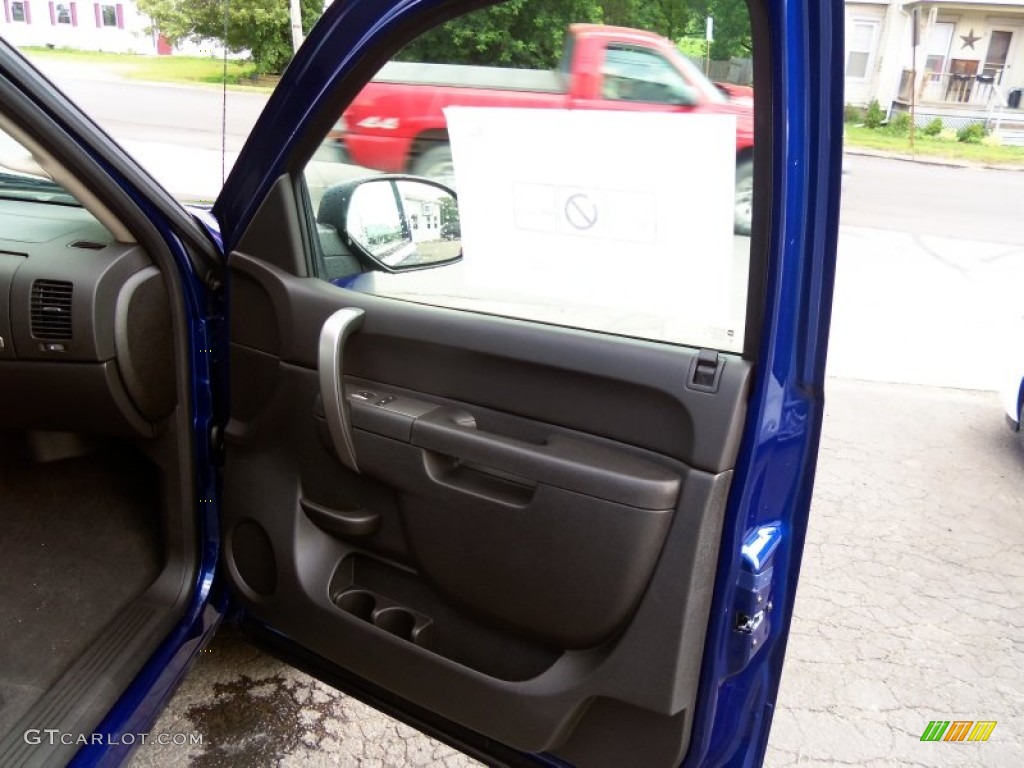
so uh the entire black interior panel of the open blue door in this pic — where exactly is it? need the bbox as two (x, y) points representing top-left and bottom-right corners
(223, 254), (750, 765)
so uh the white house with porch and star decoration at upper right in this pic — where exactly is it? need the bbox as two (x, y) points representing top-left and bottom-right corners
(846, 0), (1024, 128)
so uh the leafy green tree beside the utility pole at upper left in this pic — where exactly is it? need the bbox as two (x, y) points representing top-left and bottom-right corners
(138, 0), (324, 73)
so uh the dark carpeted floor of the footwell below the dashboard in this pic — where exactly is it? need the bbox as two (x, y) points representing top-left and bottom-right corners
(0, 435), (162, 733)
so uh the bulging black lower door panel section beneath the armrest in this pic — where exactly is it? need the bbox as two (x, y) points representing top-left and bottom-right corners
(355, 423), (672, 648)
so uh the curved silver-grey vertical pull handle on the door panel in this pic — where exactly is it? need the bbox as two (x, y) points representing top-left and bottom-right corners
(317, 307), (366, 472)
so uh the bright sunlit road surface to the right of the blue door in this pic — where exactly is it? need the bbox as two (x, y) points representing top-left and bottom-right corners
(828, 155), (1024, 389)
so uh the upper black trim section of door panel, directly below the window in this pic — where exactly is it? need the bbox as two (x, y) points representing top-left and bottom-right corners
(230, 253), (751, 472)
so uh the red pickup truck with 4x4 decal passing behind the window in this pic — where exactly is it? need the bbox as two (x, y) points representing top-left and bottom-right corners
(332, 24), (754, 233)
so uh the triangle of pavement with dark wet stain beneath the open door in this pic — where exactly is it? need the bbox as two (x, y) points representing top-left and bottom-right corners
(131, 627), (478, 768)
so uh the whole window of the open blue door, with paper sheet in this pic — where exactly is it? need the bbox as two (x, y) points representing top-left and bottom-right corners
(305, 0), (754, 351)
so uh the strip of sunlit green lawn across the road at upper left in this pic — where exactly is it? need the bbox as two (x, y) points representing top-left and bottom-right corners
(22, 47), (272, 87)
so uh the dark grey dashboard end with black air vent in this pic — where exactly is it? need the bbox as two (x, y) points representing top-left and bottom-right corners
(0, 199), (176, 437)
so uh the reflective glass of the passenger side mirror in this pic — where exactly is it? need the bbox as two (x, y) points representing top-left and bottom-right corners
(345, 176), (462, 271)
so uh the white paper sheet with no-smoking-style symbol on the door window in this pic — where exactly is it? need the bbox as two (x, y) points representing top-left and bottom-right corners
(444, 106), (736, 328)
